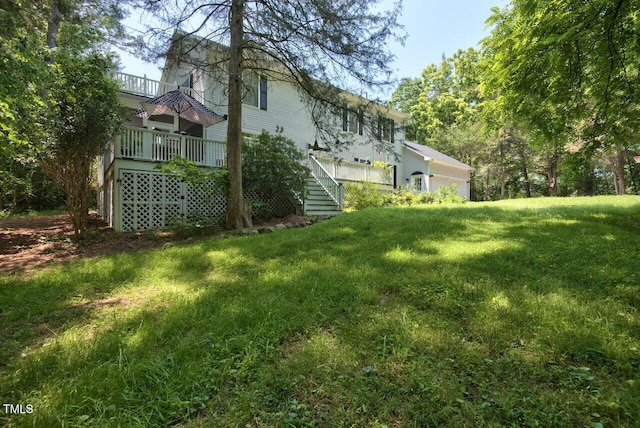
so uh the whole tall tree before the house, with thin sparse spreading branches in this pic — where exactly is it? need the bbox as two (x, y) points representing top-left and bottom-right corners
(132, 0), (400, 228)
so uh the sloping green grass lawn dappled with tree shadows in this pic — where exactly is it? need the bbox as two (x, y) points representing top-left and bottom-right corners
(0, 196), (640, 427)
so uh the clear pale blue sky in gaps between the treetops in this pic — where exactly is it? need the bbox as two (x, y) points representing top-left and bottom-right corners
(114, 0), (508, 93)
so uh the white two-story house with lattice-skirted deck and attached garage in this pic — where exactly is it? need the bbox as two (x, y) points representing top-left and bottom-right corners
(98, 35), (471, 230)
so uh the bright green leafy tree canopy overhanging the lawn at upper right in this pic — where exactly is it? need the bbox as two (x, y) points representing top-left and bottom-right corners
(483, 0), (640, 194)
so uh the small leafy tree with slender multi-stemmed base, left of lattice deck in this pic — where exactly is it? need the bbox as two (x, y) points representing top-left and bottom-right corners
(43, 52), (123, 236)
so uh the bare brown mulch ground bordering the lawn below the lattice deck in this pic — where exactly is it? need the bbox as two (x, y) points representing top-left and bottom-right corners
(0, 212), (316, 272)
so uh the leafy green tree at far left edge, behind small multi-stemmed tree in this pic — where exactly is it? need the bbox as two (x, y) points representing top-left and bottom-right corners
(0, 0), (131, 209)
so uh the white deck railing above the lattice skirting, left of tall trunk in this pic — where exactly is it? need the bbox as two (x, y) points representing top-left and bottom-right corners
(114, 126), (226, 167)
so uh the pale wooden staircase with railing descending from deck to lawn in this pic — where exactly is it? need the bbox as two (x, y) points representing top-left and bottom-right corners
(304, 156), (342, 216)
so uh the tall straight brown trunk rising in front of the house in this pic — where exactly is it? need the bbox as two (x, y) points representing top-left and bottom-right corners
(226, 0), (244, 229)
